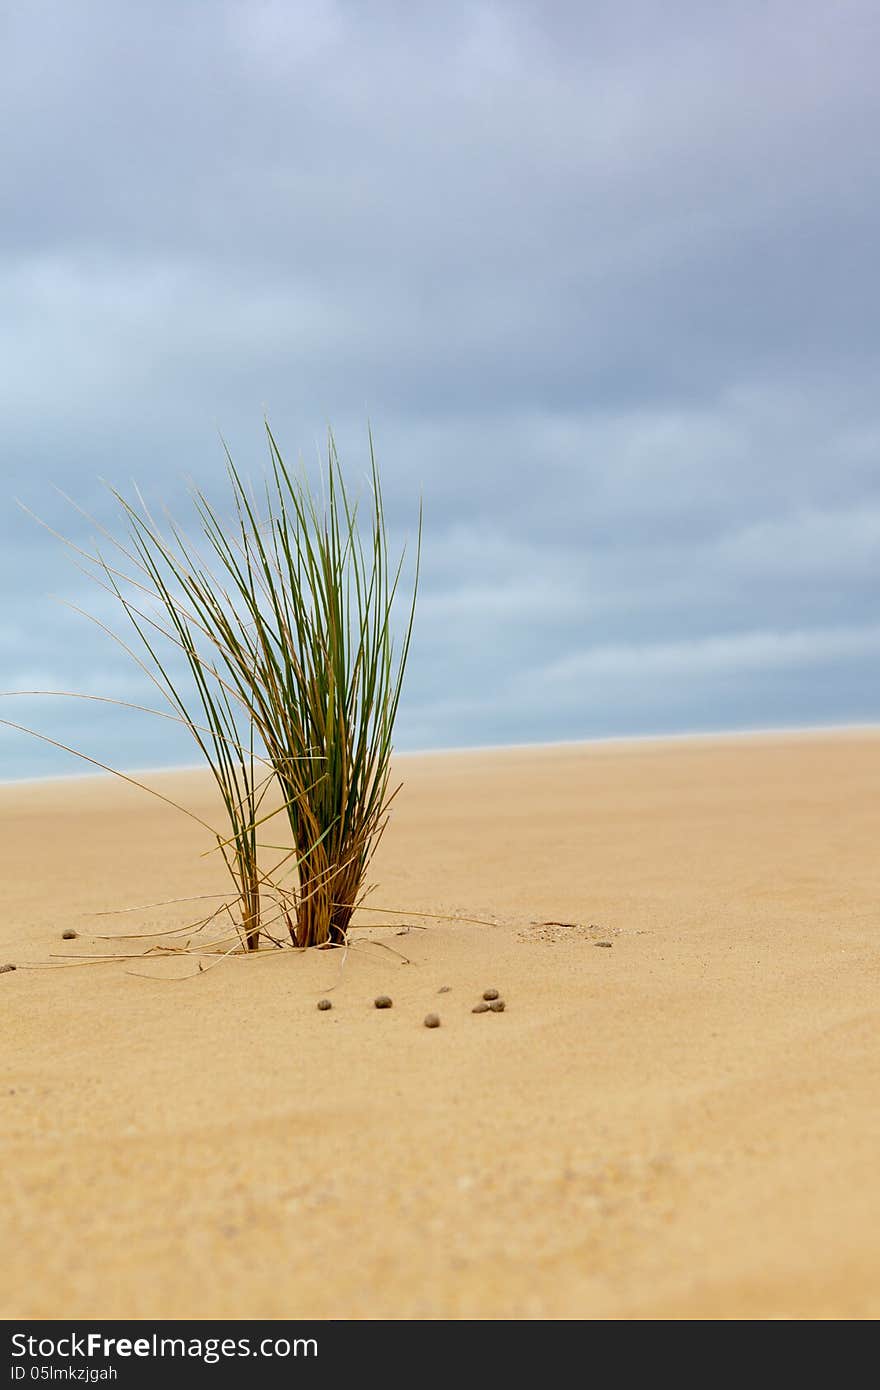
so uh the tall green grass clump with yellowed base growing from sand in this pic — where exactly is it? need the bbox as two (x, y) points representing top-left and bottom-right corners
(9, 424), (421, 951)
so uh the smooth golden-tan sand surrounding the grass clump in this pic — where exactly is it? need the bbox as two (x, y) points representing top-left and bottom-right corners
(0, 731), (880, 1319)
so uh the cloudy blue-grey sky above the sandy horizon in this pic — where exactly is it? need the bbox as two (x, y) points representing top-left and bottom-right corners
(0, 0), (880, 778)
